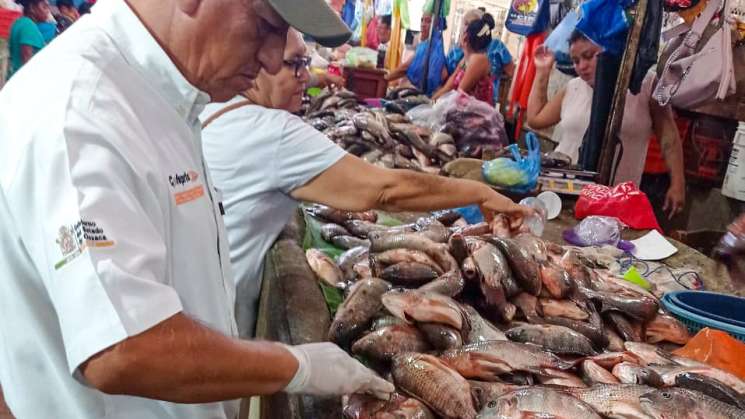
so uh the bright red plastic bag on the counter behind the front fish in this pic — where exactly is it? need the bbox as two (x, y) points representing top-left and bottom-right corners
(574, 182), (662, 233)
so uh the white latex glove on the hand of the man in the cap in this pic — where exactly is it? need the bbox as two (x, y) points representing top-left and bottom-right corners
(284, 342), (395, 399)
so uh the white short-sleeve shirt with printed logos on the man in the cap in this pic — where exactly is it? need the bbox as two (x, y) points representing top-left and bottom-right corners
(0, 0), (238, 419)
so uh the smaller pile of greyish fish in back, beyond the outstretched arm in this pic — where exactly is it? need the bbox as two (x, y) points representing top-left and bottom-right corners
(306, 89), (458, 174)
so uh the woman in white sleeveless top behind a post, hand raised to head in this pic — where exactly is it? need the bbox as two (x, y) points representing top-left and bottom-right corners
(527, 31), (685, 216)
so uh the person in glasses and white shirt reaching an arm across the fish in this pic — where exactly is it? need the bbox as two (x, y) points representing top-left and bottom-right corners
(202, 31), (526, 336)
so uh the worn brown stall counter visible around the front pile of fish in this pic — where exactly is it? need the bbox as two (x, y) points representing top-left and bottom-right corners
(257, 203), (742, 418)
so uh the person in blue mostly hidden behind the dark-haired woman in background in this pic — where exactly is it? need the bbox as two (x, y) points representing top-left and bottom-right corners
(447, 8), (515, 103)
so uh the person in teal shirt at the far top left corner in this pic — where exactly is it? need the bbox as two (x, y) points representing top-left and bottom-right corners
(8, 0), (50, 79)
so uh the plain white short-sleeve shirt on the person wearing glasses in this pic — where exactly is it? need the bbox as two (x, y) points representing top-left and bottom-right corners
(202, 98), (346, 336)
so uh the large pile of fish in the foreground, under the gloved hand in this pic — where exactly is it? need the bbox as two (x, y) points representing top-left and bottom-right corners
(306, 205), (745, 419)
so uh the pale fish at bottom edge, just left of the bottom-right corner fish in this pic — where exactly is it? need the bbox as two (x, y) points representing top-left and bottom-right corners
(563, 384), (654, 419)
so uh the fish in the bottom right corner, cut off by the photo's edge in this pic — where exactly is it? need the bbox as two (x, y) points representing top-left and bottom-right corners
(639, 388), (745, 419)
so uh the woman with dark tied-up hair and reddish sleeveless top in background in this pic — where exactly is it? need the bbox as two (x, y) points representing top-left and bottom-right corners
(432, 13), (494, 105)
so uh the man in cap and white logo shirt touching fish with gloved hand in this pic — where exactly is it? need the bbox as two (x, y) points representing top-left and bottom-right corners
(0, 0), (393, 419)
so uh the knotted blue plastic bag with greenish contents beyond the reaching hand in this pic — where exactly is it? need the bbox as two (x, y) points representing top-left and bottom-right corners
(482, 132), (541, 193)
